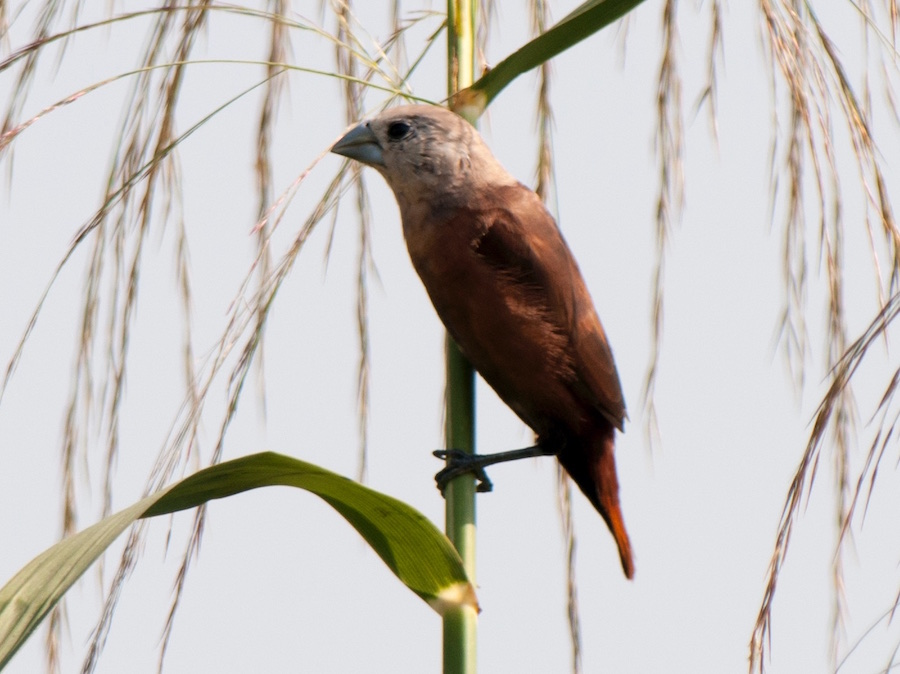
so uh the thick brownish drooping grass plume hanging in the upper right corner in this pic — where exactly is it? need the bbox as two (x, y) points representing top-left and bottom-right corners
(760, 1), (900, 387)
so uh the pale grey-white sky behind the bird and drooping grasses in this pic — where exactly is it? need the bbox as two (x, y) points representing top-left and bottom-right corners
(0, 0), (900, 674)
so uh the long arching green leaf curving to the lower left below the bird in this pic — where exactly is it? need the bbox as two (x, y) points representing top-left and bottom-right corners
(0, 452), (477, 669)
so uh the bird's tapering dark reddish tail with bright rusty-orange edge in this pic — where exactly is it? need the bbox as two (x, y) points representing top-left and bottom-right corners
(559, 424), (634, 579)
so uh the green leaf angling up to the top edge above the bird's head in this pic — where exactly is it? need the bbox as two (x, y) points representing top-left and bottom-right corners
(451, 0), (643, 119)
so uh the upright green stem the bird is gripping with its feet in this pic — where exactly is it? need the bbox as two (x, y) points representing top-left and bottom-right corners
(444, 0), (478, 674)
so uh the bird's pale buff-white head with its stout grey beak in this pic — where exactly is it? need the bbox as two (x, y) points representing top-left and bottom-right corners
(331, 105), (516, 211)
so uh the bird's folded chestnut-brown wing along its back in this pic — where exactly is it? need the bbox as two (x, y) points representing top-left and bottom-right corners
(472, 185), (626, 430)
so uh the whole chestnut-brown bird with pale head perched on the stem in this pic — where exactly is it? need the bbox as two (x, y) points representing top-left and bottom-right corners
(331, 104), (634, 579)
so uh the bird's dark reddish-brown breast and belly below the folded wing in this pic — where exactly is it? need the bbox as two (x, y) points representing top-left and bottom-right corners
(404, 206), (585, 434)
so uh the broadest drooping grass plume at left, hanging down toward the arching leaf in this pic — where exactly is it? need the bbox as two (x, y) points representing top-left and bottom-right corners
(62, 8), (217, 668)
